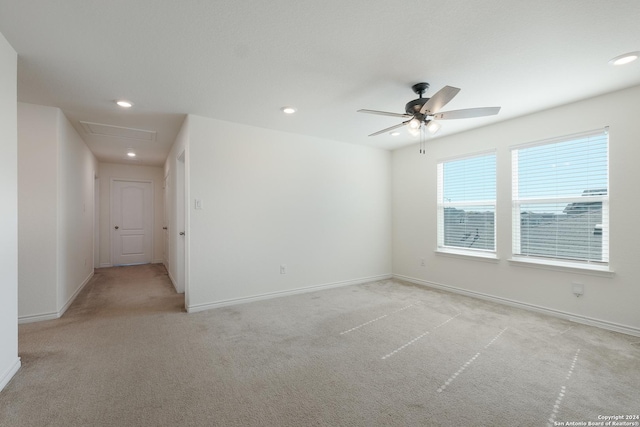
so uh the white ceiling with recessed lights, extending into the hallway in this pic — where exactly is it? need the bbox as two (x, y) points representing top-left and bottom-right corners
(0, 0), (640, 165)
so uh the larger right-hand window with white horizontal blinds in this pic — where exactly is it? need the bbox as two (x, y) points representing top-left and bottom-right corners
(511, 129), (609, 265)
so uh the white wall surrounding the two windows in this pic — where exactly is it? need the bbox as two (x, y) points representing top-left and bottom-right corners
(392, 87), (640, 335)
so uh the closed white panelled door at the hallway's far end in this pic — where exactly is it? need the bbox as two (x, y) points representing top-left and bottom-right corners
(111, 180), (153, 265)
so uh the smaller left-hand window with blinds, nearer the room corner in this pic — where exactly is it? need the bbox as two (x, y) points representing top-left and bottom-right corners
(438, 153), (496, 255)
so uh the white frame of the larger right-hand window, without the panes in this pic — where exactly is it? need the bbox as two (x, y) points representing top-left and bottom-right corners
(510, 127), (610, 272)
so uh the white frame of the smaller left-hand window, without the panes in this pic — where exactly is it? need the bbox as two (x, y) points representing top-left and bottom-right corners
(436, 150), (498, 259)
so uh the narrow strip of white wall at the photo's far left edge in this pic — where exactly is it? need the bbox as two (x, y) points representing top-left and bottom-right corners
(0, 30), (20, 390)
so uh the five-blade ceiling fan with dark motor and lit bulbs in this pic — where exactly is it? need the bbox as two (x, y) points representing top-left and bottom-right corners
(358, 83), (500, 151)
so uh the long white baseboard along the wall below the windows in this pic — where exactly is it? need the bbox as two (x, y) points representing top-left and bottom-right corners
(393, 274), (640, 337)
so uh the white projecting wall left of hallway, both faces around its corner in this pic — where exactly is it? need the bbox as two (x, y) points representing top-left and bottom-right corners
(18, 103), (98, 322)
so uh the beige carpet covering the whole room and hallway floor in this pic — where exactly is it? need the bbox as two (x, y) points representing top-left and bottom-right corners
(0, 265), (640, 426)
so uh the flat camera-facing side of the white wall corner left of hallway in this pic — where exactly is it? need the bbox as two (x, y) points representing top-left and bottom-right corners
(18, 103), (59, 315)
